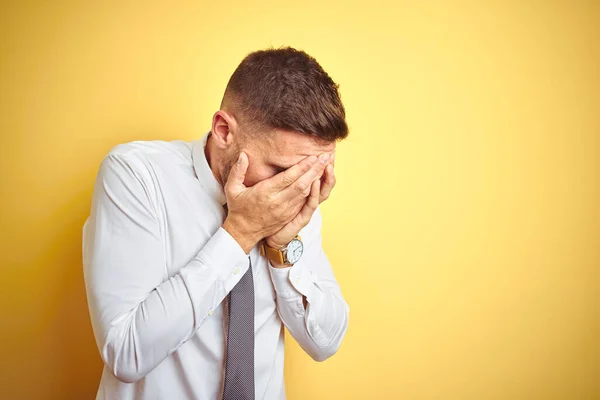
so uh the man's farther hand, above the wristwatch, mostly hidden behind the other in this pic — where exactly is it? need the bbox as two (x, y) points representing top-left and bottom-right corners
(265, 152), (335, 252)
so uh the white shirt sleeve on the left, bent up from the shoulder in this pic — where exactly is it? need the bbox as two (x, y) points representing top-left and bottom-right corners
(83, 153), (250, 383)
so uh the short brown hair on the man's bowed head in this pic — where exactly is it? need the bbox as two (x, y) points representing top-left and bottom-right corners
(221, 47), (348, 142)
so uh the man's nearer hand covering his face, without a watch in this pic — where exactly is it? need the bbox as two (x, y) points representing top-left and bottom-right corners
(223, 152), (329, 254)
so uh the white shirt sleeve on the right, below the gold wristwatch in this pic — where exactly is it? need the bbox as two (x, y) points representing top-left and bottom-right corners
(269, 207), (350, 361)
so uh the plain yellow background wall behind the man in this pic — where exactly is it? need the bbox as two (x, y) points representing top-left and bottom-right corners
(0, 0), (600, 400)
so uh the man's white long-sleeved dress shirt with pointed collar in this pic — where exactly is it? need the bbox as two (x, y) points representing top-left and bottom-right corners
(83, 131), (349, 400)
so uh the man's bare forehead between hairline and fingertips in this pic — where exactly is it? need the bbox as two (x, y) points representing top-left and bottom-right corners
(263, 130), (336, 166)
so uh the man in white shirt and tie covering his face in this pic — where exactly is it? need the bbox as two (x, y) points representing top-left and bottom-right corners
(83, 48), (349, 400)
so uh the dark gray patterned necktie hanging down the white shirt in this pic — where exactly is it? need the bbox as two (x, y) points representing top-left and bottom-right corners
(223, 204), (254, 400)
